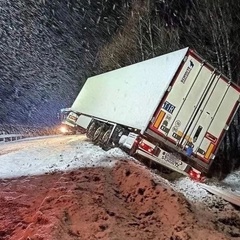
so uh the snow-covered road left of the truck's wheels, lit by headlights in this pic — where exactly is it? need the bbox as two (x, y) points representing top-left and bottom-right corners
(0, 135), (130, 178)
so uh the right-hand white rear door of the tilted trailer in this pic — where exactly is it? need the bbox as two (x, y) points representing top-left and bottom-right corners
(187, 79), (239, 163)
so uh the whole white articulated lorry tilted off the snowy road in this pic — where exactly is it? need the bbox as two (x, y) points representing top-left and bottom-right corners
(61, 48), (240, 179)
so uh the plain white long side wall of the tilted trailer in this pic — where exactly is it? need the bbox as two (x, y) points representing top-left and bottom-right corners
(71, 48), (188, 130)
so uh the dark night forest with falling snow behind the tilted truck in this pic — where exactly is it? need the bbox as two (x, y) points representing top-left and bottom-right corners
(0, 0), (240, 176)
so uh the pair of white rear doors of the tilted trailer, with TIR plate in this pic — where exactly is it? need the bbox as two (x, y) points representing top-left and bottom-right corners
(150, 52), (239, 168)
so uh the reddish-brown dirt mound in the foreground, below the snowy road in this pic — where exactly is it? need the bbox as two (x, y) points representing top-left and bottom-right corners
(0, 161), (238, 240)
